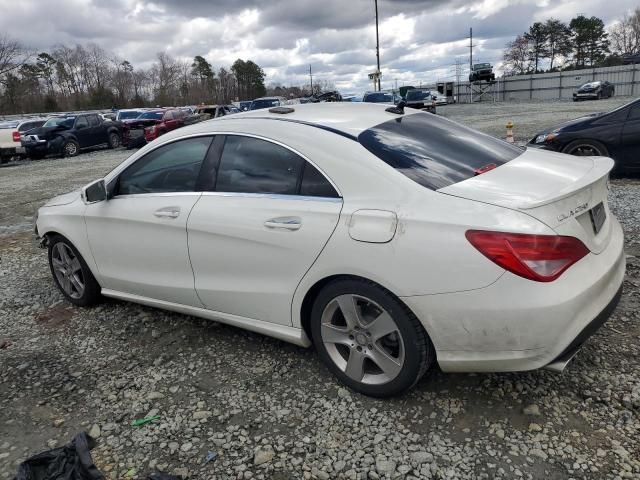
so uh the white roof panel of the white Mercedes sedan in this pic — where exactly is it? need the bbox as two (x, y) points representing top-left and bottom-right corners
(215, 102), (420, 136)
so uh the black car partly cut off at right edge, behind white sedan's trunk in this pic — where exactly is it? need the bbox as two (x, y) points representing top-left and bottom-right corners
(528, 99), (640, 173)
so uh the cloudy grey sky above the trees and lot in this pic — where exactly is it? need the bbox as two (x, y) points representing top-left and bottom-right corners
(0, 0), (638, 93)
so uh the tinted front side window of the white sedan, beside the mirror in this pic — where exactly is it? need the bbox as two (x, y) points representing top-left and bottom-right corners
(115, 136), (213, 196)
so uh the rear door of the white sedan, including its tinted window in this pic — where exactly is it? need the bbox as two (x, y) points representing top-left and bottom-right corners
(187, 135), (342, 325)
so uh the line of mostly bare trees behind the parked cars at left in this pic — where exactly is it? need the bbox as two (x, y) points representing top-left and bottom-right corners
(0, 36), (266, 114)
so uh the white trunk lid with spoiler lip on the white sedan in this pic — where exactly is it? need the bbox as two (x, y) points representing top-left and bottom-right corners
(438, 149), (613, 253)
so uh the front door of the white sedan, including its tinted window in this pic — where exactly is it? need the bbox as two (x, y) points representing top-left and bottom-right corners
(85, 136), (212, 307)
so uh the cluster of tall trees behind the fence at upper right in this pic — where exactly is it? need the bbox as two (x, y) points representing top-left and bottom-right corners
(503, 8), (640, 75)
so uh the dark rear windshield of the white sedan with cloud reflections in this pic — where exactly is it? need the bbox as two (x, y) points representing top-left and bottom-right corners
(358, 113), (523, 190)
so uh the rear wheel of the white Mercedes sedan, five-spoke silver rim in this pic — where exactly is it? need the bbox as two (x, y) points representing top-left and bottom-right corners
(311, 279), (435, 397)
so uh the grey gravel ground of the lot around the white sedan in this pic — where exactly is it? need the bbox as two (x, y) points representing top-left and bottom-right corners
(0, 98), (640, 480)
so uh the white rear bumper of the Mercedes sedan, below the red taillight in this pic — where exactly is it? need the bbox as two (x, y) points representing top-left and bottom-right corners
(402, 219), (625, 372)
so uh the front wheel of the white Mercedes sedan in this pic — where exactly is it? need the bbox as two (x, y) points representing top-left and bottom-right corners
(48, 235), (101, 307)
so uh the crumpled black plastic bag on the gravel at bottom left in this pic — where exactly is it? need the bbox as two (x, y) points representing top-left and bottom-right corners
(14, 432), (105, 480)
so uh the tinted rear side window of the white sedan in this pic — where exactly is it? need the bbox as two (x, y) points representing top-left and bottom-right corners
(215, 135), (338, 197)
